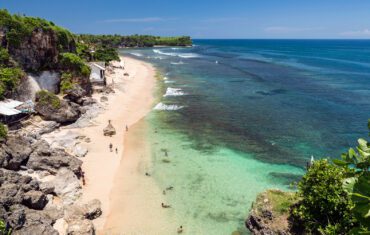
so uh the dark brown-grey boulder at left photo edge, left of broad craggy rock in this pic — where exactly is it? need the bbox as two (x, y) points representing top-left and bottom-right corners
(0, 135), (32, 170)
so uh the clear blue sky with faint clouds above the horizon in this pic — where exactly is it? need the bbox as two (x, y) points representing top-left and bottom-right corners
(0, 0), (370, 39)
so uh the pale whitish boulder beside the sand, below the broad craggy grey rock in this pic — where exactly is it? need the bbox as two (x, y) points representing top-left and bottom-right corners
(52, 168), (82, 205)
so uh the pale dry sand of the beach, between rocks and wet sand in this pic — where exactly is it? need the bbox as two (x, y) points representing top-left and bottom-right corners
(74, 57), (155, 234)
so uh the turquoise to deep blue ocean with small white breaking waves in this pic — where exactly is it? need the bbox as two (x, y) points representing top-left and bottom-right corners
(121, 40), (370, 234)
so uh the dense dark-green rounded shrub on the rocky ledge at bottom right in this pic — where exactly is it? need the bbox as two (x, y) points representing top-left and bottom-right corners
(292, 160), (353, 234)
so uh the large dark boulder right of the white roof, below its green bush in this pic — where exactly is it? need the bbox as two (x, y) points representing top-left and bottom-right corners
(35, 100), (81, 124)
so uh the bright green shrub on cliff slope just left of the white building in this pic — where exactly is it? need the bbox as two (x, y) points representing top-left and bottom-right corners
(60, 53), (91, 77)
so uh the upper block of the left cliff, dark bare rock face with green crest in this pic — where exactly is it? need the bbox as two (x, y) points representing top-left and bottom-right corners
(0, 10), (76, 71)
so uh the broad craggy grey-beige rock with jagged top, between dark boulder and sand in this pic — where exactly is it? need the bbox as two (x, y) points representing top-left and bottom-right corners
(27, 140), (82, 175)
